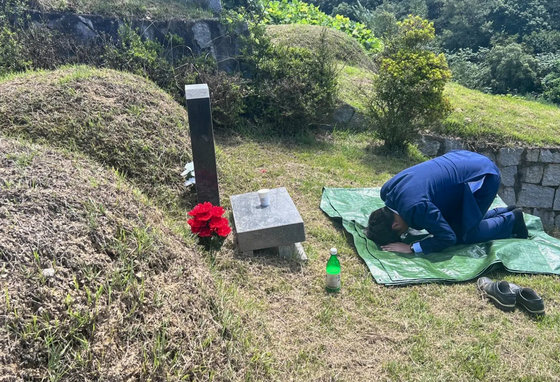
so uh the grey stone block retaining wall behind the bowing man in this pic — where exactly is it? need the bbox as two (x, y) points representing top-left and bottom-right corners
(418, 135), (560, 228)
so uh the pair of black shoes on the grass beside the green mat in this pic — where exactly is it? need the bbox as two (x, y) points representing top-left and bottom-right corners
(476, 277), (544, 314)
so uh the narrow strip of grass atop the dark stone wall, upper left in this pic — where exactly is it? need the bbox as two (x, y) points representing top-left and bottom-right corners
(32, 0), (212, 20)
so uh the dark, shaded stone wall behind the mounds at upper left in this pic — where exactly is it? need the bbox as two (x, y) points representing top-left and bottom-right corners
(24, 11), (243, 71)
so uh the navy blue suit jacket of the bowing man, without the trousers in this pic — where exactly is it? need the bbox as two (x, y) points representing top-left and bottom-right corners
(381, 150), (500, 253)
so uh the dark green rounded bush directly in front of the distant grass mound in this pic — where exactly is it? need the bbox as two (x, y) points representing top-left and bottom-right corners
(242, 26), (337, 133)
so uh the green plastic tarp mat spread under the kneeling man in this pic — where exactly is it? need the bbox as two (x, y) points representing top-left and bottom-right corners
(321, 188), (560, 285)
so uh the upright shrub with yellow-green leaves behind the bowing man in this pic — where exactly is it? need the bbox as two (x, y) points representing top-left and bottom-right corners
(368, 16), (451, 151)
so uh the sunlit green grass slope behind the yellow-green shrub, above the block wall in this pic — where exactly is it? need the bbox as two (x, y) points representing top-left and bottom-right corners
(339, 66), (560, 146)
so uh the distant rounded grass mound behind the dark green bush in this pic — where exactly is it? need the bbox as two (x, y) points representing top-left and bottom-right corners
(266, 24), (372, 68)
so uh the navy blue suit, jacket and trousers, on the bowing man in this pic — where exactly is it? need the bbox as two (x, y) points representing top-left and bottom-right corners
(381, 150), (514, 253)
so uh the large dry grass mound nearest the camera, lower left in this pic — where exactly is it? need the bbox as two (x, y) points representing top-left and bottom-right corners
(0, 138), (225, 381)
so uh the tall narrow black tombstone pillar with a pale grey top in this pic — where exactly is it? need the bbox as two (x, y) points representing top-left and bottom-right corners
(185, 84), (220, 206)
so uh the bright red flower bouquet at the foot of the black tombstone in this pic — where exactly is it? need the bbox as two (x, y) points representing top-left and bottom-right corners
(187, 202), (231, 249)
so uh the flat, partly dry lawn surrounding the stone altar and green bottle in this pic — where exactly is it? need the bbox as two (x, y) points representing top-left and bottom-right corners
(207, 130), (560, 381)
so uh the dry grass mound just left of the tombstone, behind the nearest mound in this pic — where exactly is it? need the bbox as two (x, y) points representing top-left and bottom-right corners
(0, 66), (191, 194)
